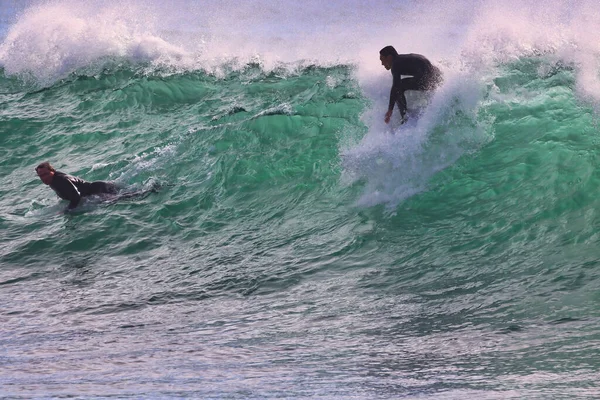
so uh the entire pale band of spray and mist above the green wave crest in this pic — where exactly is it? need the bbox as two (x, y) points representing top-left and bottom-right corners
(0, 0), (600, 83)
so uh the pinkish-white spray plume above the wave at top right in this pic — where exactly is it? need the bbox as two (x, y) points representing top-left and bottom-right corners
(452, 0), (600, 109)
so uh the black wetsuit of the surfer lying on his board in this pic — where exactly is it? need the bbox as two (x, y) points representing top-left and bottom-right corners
(49, 171), (117, 209)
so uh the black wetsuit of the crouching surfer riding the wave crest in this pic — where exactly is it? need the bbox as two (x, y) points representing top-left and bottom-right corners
(388, 54), (442, 121)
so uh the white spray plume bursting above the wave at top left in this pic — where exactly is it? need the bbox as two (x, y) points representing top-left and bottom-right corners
(0, 2), (191, 84)
